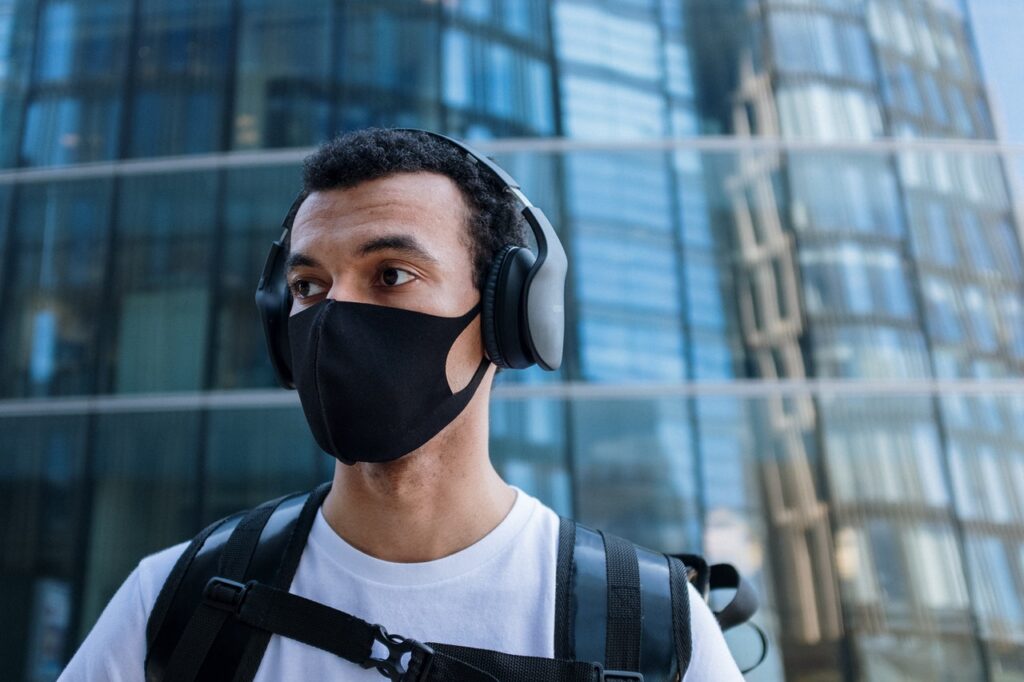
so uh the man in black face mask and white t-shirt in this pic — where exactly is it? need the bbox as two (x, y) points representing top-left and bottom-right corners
(61, 129), (740, 682)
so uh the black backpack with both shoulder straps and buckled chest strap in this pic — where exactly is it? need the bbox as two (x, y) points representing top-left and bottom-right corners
(145, 482), (764, 682)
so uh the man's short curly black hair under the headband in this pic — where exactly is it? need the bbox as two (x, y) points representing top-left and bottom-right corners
(302, 128), (525, 291)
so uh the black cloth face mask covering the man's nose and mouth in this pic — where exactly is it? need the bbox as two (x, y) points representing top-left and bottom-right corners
(288, 300), (487, 464)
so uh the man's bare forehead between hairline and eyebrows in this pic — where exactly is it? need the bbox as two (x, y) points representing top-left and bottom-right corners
(292, 172), (468, 248)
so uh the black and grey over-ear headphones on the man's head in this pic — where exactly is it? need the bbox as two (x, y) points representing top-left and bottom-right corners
(256, 128), (567, 388)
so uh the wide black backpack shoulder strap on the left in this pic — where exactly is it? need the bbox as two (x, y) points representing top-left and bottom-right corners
(145, 477), (330, 682)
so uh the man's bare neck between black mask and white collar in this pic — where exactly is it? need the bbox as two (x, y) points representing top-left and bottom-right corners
(324, 393), (515, 562)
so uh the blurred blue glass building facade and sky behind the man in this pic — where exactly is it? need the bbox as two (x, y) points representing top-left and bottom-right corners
(0, 0), (1024, 682)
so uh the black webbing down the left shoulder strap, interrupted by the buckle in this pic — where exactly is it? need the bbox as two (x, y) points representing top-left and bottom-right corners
(165, 496), (291, 682)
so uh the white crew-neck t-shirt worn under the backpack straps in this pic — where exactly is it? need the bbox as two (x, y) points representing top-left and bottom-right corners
(58, 491), (742, 682)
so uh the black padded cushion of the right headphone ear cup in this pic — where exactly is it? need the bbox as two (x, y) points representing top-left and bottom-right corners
(480, 244), (537, 370)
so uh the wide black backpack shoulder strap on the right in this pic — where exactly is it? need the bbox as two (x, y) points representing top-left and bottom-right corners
(555, 518), (690, 681)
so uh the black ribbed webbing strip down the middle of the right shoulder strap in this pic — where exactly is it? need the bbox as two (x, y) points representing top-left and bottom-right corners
(601, 532), (643, 672)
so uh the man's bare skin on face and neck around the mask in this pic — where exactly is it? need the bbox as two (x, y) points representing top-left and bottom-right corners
(288, 172), (515, 562)
